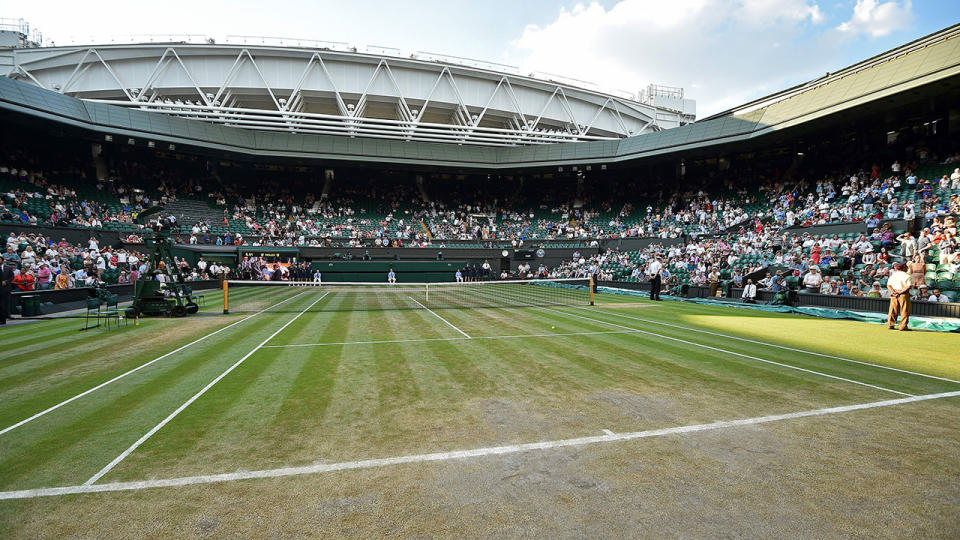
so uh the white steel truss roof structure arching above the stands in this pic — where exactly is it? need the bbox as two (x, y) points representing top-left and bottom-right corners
(0, 40), (693, 146)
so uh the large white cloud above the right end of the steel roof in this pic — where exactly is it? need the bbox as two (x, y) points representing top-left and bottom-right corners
(507, 0), (835, 117)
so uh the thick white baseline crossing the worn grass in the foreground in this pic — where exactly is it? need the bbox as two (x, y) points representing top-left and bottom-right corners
(0, 391), (960, 500)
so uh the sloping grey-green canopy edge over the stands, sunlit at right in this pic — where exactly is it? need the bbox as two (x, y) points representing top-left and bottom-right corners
(0, 24), (960, 169)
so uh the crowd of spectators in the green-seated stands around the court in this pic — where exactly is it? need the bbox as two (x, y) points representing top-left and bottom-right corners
(0, 129), (960, 304)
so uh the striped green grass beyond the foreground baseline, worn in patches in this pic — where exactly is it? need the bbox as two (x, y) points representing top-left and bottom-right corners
(0, 288), (960, 534)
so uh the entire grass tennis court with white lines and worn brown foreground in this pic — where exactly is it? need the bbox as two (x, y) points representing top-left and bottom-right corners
(0, 282), (960, 535)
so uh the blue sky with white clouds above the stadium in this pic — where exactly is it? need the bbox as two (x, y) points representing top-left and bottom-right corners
(7, 0), (960, 118)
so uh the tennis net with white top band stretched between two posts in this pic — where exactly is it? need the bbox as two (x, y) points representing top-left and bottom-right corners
(223, 279), (593, 313)
